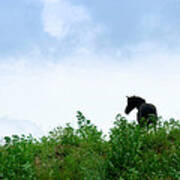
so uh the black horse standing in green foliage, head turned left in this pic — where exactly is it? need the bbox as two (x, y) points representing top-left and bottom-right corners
(125, 96), (157, 127)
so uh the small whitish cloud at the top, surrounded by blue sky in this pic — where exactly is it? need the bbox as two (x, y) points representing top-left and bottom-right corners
(42, 0), (100, 43)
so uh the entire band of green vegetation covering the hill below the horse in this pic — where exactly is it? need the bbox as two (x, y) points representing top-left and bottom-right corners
(0, 112), (180, 180)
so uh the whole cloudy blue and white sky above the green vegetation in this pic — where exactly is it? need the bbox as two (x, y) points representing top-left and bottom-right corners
(0, 0), (180, 137)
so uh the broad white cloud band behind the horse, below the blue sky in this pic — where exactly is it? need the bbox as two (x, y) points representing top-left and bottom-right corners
(0, 45), (180, 136)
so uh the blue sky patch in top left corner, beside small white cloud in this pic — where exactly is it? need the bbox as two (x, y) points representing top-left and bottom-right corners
(0, 0), (43, 56)
